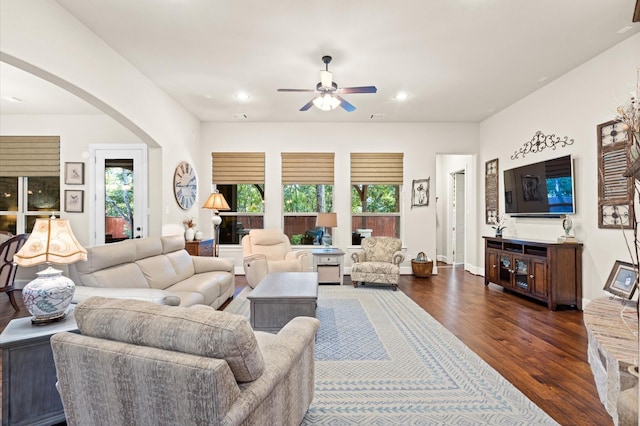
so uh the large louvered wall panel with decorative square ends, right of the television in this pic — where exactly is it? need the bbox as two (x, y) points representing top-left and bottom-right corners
(597, 120), (634, 229)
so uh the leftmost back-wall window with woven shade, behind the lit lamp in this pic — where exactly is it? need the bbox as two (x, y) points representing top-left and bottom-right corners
(211, 152), (264, 244)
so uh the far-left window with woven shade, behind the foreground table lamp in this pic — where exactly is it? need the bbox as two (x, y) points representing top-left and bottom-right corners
(0, 136), (60, 235)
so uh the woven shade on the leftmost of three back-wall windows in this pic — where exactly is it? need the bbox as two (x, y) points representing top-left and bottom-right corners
(211, 152), (264, 185)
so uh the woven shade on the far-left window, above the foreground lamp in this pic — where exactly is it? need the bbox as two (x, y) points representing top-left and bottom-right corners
(0, 136), (60, 176)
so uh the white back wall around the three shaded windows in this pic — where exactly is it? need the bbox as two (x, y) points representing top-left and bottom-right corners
(198, 121), (478, 273)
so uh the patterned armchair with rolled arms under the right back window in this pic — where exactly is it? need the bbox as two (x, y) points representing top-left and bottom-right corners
(351, 237), (404, 291)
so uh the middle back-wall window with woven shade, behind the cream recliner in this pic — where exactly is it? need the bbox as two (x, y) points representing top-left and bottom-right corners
(282, 152), (335, 245)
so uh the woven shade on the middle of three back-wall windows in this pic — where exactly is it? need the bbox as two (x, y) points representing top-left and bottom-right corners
(282, 152), (335, 185)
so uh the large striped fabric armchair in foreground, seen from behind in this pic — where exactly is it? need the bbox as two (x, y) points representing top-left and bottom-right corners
(51, 297), (320, 426)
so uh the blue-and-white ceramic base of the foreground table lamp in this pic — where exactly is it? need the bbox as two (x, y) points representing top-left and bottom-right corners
(22, 267), (76, 324)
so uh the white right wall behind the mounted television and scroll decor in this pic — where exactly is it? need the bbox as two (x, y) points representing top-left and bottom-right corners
(476, 34), (640, 300)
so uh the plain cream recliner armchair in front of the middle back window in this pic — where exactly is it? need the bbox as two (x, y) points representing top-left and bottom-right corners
(242, 229), (308, 288)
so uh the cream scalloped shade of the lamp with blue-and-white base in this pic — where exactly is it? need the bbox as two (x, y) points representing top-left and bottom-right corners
(13, 219), (87, 266)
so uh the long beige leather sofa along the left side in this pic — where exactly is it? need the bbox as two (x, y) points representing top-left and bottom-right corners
(69, 235), (235, 308)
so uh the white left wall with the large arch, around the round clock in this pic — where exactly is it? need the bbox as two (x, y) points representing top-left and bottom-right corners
(0, 0), (201, 235)
